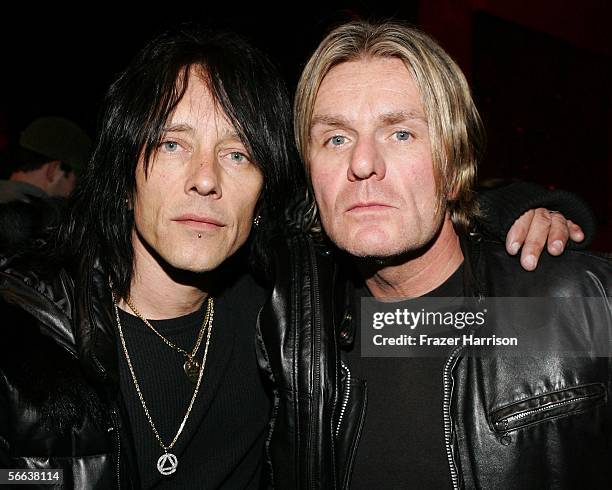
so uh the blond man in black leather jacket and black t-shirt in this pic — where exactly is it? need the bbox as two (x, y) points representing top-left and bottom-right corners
(260, 22), (612, 489)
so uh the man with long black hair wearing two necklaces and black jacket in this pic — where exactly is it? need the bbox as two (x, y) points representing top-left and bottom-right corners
(0, 22), (592, 489)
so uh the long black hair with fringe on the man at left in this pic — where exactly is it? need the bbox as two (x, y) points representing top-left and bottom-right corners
(57, 24), (303, 296)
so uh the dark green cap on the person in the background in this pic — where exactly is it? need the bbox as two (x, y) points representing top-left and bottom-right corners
(19, 117), (91, 173)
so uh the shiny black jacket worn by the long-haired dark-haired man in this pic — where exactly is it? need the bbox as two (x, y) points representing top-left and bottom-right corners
(0, 260), (139, 490)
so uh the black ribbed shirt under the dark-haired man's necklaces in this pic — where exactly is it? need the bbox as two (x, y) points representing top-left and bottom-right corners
(118, 275), (271, 489)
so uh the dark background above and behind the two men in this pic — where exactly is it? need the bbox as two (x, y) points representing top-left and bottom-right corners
(0, 0), (612, 250)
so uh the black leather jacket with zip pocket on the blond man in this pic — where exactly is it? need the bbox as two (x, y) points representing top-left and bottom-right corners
(259, 236), (612, 489)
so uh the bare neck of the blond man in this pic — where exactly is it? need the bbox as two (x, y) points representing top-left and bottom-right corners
(365, 216), (463, 298)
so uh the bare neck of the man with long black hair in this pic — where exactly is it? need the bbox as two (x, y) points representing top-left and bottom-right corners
(119, 233), (208, 320)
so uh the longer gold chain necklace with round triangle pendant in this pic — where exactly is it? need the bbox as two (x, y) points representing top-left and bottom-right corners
(113, 292), (215, 476)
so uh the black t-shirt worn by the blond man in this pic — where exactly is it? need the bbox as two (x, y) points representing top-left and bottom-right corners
(347, 265), (463, 490)
